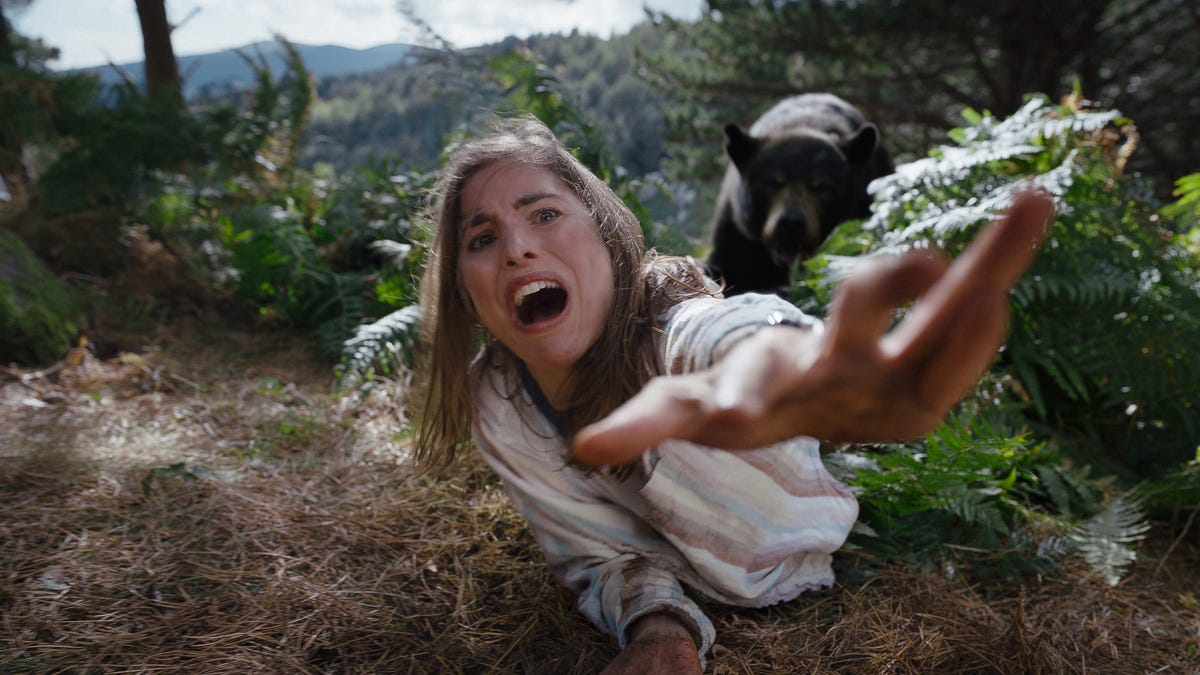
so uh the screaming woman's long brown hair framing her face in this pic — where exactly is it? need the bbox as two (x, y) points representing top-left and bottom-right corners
(413, 117), (709, 466)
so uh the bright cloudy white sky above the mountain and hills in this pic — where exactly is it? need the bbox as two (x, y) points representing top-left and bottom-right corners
(14, 0), (703, 70)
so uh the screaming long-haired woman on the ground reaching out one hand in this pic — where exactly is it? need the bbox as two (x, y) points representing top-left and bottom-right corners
(418, 119), (1049, 673)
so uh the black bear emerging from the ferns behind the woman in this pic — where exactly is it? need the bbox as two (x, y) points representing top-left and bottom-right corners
(708, 94), (894, 294)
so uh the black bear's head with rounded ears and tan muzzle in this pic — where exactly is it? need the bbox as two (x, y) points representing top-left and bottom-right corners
(725, 124), (878, 267)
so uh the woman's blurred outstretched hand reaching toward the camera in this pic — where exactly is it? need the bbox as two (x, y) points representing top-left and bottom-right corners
(574, 193), (1054, 466)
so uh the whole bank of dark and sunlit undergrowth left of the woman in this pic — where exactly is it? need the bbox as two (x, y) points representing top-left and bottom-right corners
(2, 34), (430, 360)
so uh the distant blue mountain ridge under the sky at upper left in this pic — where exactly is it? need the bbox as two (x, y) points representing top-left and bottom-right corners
(76, 42), (420, 97)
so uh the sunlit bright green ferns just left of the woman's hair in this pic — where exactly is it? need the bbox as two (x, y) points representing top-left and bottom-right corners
(199, 153), (430, 360)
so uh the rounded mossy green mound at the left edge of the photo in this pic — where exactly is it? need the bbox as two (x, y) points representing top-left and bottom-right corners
(0, 231), (82, 364)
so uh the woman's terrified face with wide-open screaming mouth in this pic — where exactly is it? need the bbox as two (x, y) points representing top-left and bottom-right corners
(458, 161), (613, 405)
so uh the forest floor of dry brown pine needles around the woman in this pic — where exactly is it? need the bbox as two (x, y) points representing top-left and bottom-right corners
(0, 322), (1200, 674)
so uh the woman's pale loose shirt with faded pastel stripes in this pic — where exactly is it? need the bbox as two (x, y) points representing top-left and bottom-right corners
(473, 294), (858, 656)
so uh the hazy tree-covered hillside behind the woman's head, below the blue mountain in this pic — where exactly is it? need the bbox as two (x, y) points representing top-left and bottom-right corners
(302, 26), (676, 177)
